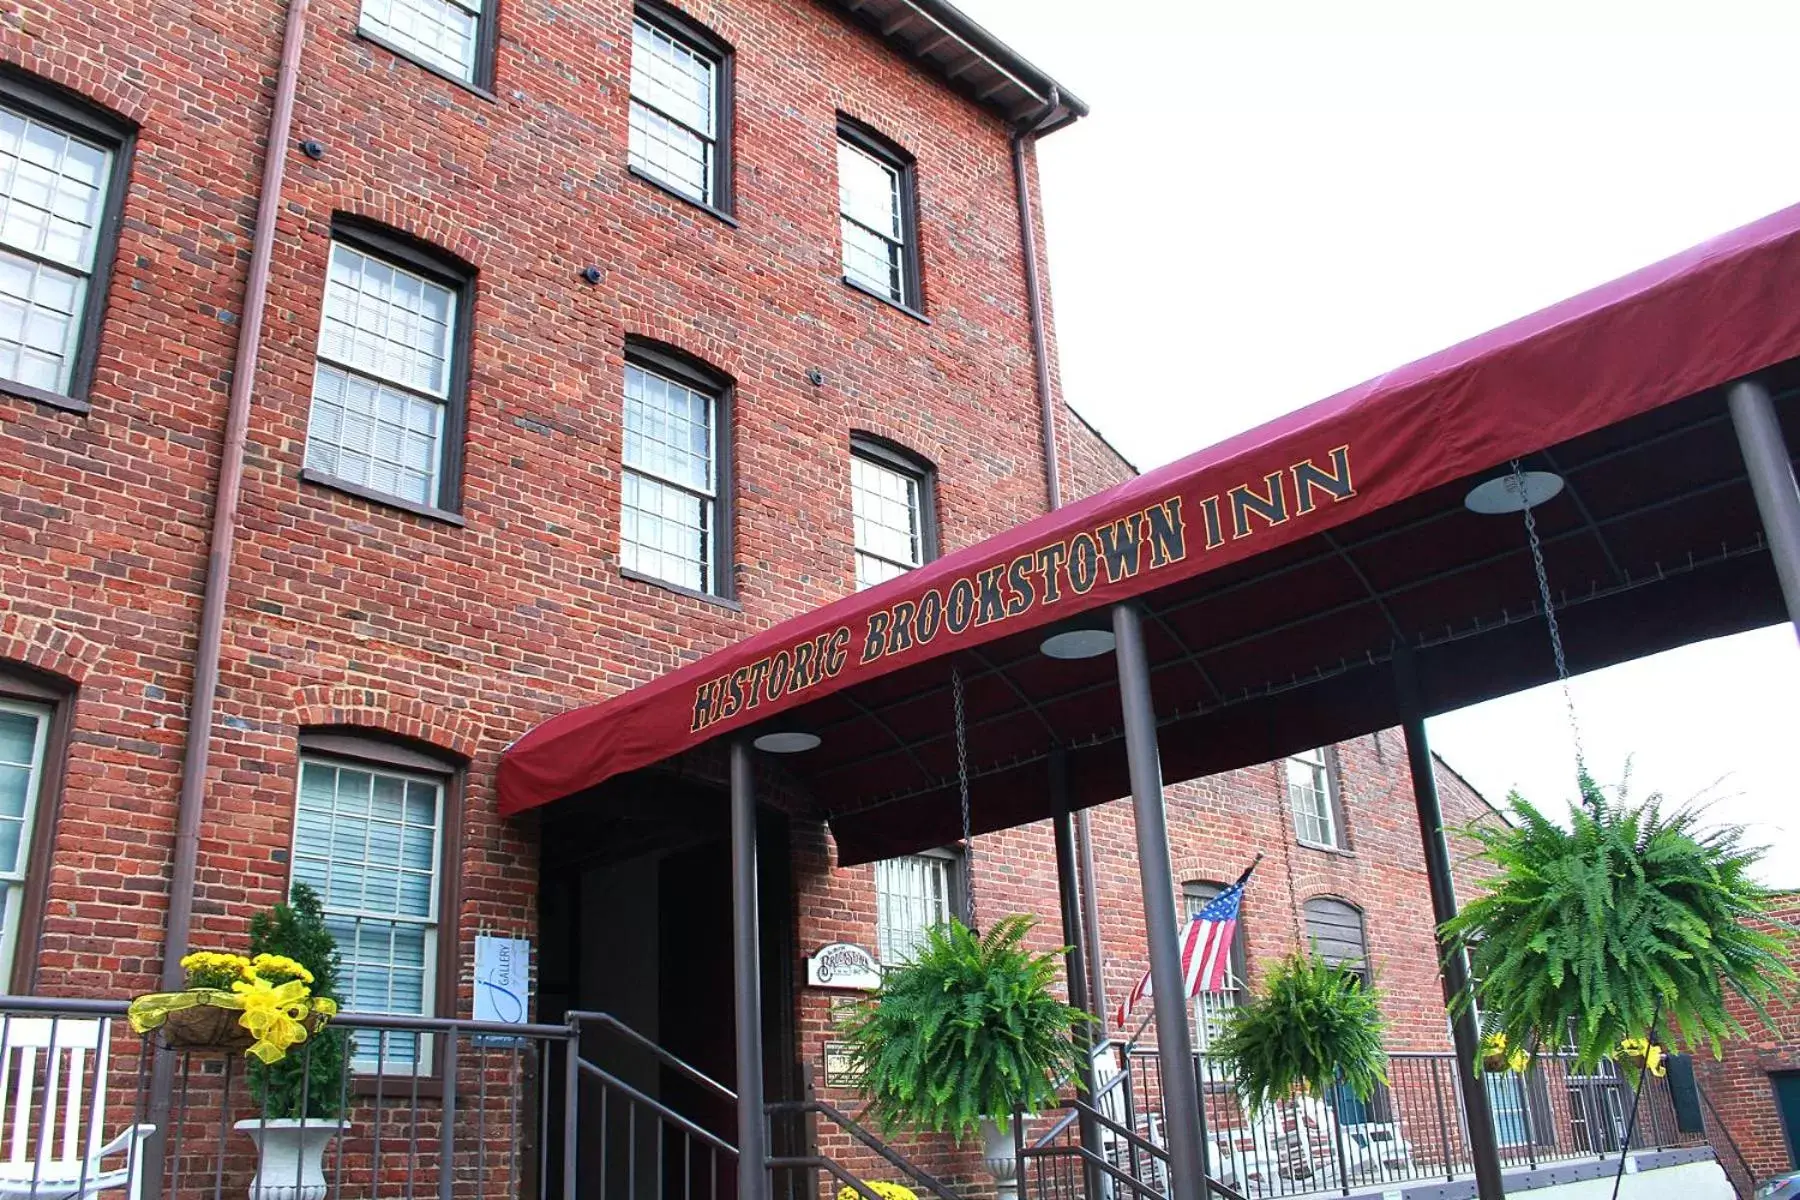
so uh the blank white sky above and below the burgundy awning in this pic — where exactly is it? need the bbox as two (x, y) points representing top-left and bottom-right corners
(961, 0), (1800, 887)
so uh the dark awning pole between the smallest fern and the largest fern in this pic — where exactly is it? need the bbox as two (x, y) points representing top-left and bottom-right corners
(1393, 644), (1507, 1200)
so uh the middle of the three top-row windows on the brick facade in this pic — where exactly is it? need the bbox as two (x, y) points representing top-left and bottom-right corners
(630, 11), (729, 209)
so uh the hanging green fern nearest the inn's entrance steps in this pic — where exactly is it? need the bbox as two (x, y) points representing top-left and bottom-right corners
(841, 916), (1087, 1137)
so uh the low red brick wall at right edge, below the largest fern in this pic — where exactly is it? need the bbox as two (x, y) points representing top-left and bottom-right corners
(1694, 892), (1800, 1196)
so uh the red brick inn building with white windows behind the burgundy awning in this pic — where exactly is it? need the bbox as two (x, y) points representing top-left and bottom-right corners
(0, 0), (1548, 1194)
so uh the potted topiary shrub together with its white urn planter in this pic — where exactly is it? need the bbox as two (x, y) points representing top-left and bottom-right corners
(234, 883), (349, 1200)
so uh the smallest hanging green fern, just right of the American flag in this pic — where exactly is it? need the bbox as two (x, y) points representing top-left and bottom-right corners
(1210, 950), (1388, 1108)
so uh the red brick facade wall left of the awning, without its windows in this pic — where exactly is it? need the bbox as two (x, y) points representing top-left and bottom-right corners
(0, 0), (1065, 995)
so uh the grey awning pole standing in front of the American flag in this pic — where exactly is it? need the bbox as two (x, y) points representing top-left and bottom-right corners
(1112, 604), (1208, 1200)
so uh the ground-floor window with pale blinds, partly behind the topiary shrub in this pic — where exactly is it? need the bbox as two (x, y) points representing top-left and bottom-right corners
(293, 754), (446, 1074)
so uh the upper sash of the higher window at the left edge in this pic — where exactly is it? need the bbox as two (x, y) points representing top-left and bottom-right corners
(0, 108), (112, 273)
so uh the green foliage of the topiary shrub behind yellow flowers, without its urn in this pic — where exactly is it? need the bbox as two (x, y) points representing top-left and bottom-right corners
(250, 883), (346, 1119)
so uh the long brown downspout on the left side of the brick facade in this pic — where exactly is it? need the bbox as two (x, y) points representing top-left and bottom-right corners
(162, 0), (308, 991)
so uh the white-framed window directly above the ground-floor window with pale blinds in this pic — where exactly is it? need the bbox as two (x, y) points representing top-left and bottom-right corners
(306, 241), (457, 507)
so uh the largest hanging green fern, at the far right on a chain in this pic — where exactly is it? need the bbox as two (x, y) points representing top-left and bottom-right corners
(1444, 772), (1795, 1067)
